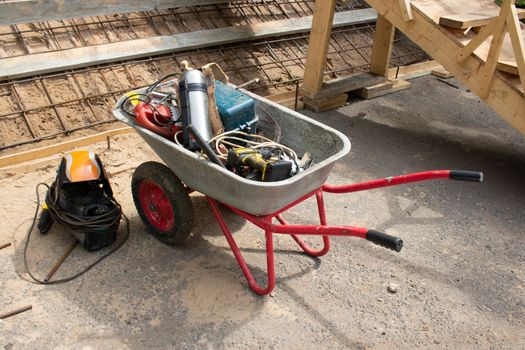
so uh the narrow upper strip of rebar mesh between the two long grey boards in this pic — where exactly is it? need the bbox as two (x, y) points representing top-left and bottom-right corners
(0, 0), (368, 58)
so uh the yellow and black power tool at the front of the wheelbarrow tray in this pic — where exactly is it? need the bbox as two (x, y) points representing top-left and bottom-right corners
(227, 147), (292, 182)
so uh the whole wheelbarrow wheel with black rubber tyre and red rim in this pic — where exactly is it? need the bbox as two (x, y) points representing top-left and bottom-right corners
(131, 162), (193, 245)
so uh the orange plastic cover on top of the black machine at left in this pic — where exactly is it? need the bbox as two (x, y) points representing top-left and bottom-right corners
(64, 151), (102, 182)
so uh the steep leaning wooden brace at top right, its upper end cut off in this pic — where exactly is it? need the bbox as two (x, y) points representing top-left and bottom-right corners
(479, 0), (515, 99)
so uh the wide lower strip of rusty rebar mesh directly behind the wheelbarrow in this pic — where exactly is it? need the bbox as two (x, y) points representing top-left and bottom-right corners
(0, 25), (422, 150)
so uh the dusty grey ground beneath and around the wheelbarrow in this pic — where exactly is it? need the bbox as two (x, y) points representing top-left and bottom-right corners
(0, 77), (525, 350)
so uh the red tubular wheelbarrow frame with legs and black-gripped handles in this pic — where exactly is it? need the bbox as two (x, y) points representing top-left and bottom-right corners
(206, 170), (483, 295)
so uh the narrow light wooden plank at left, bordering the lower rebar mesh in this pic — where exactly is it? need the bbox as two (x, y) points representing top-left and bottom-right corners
(0, 127), (134, 168)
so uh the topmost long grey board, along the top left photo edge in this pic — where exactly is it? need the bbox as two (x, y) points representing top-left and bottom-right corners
(0, 0), (232, 25)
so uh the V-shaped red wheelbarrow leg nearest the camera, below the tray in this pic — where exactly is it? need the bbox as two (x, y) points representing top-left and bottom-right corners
(206, 197), (275, 295)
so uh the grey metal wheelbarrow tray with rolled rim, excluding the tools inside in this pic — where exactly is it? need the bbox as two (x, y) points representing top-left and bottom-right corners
(113, 90), (350, 215)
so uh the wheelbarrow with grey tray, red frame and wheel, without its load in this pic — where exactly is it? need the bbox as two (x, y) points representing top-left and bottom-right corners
(113, 86), (483, 295)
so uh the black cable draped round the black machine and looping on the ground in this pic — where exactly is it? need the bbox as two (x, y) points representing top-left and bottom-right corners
(24, 182), (130, 284)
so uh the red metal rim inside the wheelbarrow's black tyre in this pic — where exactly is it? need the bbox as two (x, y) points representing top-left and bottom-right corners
(139, 180), (175, 231)
